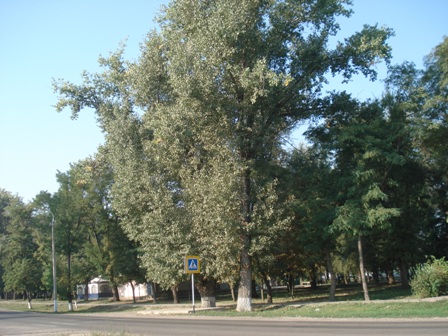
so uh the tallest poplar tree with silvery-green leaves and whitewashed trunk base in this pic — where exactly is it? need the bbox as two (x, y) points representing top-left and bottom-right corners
(56, 0), (391, 311)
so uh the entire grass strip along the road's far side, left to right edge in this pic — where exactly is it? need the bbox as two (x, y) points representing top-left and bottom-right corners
(0, 285), (448, 318)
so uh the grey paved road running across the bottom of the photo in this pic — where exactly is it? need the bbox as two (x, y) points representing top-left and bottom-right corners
(0, 311), (448, 336)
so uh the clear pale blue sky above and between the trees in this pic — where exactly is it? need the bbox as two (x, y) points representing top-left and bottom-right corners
(0, 0), (448, 201)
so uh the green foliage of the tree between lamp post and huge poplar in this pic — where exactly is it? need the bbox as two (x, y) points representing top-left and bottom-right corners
(51, 154), (145, 299)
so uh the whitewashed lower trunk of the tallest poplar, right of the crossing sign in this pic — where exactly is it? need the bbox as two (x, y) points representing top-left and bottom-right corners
(236, 234), (252, 312)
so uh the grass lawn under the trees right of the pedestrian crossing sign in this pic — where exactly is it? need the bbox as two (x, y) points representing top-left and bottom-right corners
(197, 285), (448, 318)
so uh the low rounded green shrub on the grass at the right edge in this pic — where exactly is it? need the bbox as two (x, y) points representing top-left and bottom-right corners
(410, 257), (448, 298)
